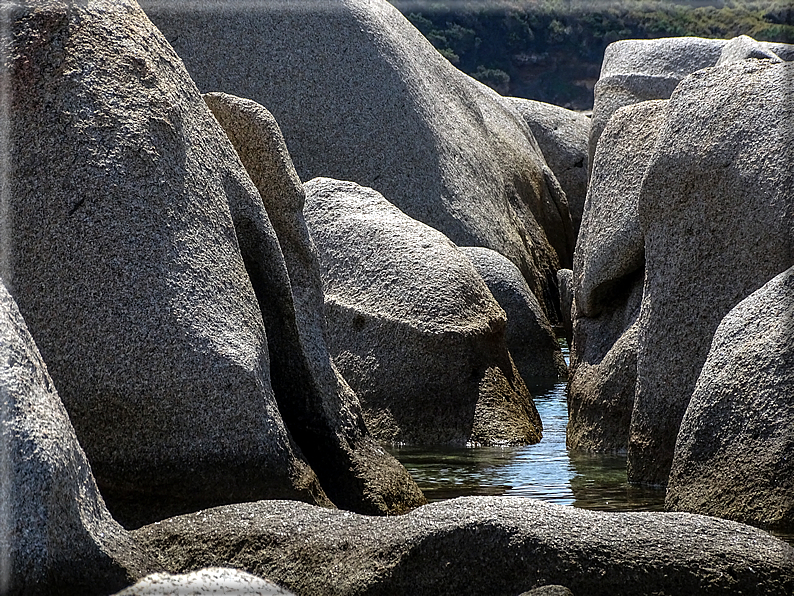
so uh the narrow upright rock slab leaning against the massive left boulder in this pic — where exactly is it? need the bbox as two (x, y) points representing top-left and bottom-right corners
(205, 93), (426, 514)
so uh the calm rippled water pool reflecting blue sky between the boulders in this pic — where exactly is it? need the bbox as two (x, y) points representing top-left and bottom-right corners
(389, 383), (794, 544)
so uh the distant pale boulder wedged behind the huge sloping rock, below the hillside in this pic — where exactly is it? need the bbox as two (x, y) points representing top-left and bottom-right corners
(507, 97), (590, 236)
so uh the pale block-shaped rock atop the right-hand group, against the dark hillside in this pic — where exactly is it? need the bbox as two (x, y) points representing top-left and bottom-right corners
(589, 37), (727, 170)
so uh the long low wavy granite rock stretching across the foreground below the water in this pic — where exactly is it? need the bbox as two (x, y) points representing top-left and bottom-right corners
(135, 497), (794, 596)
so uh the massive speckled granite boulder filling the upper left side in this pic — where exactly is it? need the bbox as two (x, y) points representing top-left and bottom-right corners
(0, 0), (328, 525)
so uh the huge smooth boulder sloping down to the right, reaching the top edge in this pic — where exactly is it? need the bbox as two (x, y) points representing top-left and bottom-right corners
(136, 0), (574, 321)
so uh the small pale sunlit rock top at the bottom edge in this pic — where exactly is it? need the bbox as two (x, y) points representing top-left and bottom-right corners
(114, 567), (294, 596)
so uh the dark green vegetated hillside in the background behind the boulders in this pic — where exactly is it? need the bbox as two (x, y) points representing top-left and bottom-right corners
(390, 0), (794, 110)
